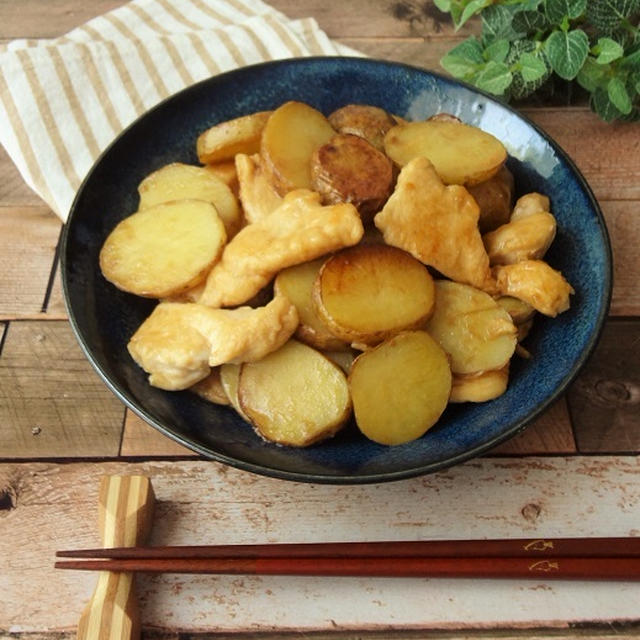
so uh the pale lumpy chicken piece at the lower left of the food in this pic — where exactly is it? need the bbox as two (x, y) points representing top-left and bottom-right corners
(128, 296), (298, 391)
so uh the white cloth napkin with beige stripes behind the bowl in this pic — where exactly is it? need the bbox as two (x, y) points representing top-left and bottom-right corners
(0, 0), (359, 221)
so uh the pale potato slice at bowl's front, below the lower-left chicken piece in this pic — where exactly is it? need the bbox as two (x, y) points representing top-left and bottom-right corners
(238, 340), (351, 447)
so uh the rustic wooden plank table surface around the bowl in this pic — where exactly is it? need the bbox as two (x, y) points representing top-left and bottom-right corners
(0, 0), (640, 638)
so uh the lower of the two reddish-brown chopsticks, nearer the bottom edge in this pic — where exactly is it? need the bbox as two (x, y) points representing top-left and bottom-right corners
(55, 556), (640, 581)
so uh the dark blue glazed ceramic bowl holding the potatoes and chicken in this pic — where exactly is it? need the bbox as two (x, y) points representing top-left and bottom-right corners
(61, 58), (611, 484)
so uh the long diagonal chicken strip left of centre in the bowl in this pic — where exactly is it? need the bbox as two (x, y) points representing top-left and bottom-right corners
(199, 189), (364, 307)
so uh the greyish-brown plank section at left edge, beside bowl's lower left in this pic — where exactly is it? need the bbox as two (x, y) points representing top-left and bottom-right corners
(0, 321), (124, 458)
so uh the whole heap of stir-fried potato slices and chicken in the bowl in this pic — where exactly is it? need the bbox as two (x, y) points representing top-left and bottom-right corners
(100, 101), (573, 447)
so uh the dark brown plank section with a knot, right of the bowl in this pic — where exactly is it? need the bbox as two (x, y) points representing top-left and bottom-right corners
(568, 319), (640, 452)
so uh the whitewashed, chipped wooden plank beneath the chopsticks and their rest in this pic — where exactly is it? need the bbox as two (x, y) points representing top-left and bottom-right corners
(0, 457), (640, 633)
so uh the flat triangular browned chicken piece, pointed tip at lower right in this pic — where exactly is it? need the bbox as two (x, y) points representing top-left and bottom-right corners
(374, 156), (494, 292)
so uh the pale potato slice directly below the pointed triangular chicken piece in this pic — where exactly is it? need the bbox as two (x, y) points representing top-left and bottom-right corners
(426, 280), (517, 374)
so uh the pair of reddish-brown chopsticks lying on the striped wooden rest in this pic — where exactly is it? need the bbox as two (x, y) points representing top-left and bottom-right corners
(55, 537), (640, 580)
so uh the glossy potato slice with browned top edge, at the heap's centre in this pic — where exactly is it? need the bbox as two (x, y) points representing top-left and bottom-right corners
(313, 244), (434, 344)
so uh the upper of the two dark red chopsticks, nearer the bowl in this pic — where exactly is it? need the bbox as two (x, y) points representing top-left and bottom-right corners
(56, 537), (640, 559)
